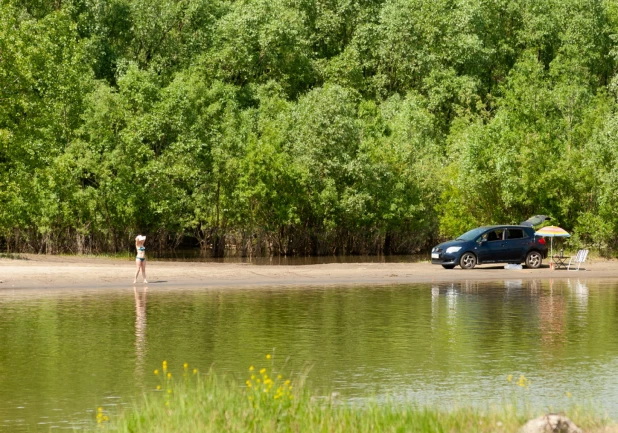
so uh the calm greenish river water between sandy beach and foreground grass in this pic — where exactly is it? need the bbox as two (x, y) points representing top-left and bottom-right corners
(0, 278), (618, 432)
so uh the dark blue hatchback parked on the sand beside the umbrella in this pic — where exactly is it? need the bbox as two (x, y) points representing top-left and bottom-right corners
(431, 225), (547, 269)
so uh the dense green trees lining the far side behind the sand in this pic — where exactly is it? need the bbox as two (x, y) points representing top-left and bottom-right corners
(0, 0), (618, 254)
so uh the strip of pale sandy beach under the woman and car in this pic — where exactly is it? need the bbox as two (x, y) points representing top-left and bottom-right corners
(0, 255), (618, 290)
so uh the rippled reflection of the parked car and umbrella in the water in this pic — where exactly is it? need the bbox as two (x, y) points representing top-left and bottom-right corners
(431, 279), (590, 366)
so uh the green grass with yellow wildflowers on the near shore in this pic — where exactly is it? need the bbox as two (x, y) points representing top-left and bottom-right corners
(91, 364), (617, 433)
